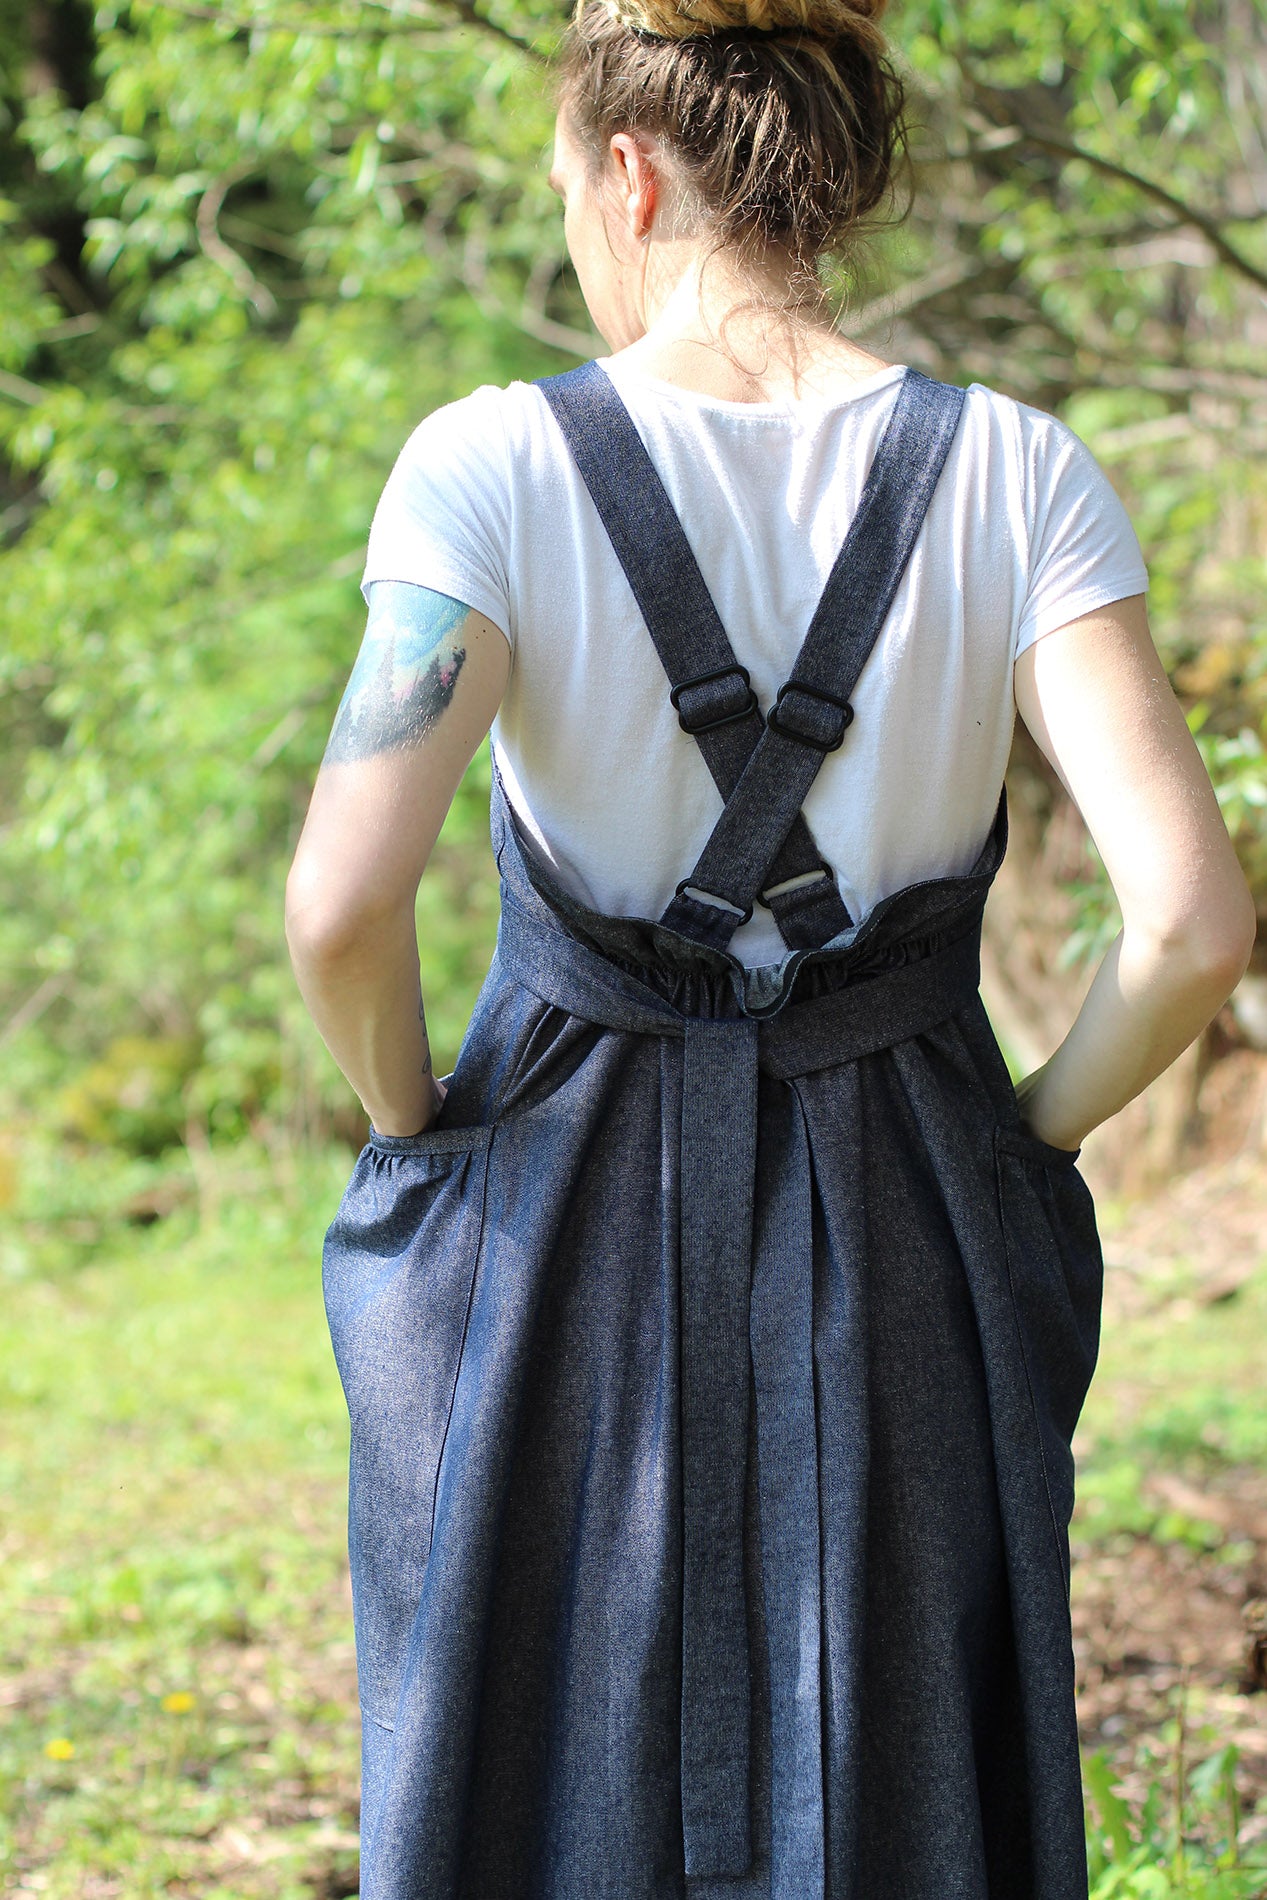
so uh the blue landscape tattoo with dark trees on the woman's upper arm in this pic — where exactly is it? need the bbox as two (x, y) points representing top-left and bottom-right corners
(323, 581), (469, 766)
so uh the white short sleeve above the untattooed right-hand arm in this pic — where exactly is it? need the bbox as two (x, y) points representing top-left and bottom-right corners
(1012, 407), (1147, 657)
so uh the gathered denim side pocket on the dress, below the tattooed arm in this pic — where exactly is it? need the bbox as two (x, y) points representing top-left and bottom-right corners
(321, 1129), (492, 1727)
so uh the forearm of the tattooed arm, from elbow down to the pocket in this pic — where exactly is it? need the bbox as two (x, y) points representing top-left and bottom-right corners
(291, 908), (439, 1134)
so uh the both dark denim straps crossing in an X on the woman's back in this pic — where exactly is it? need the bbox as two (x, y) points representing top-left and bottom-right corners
(538, 363), (965, 950)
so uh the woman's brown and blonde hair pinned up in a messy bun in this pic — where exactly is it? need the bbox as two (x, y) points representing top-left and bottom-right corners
(558, 0), (906, 268)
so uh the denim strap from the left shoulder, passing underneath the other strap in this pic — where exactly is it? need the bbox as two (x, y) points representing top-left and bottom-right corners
(538, 363), (849, 950)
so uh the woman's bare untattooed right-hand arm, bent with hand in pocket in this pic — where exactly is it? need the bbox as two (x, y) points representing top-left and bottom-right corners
(1014, 595), (1254, 1148)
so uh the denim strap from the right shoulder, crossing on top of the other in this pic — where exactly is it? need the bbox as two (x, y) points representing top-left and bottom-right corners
(661, 369), (965, 950)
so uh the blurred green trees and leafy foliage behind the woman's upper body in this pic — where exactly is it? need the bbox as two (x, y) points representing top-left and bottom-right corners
(0, 0), (1267, 1148)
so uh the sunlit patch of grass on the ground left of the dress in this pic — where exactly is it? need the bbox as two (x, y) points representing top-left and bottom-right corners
(0, 1155), (357, 1900)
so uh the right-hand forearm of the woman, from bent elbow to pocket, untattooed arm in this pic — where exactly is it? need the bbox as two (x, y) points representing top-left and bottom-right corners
(1016, 915), (1244, 1148)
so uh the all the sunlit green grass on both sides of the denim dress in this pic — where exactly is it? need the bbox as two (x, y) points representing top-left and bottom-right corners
(0, 1150), (1267, 1900)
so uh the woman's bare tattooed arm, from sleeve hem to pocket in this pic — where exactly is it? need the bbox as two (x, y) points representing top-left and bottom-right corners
(287, 581), (511, 1134)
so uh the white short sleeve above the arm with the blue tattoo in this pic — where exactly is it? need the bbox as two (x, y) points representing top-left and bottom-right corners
(361, 386), (511, 642)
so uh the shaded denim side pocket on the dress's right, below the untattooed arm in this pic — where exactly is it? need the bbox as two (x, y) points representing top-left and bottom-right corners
(993, 1127), (1104, 1581)
